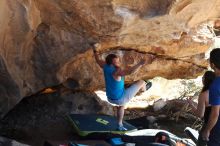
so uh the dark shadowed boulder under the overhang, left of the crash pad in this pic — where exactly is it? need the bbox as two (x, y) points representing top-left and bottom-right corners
(0, 86), (113, 146)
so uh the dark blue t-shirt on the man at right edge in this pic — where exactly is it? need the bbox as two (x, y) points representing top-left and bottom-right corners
(209, 77), (220, 130)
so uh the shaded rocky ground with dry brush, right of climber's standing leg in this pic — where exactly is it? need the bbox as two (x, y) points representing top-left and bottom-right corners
(125, 102), (200, 138)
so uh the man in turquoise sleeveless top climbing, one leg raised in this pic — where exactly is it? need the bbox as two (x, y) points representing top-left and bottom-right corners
(92, 47), (153, 131)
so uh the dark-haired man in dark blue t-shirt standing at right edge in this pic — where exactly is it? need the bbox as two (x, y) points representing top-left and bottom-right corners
(202, 48), (220, 146)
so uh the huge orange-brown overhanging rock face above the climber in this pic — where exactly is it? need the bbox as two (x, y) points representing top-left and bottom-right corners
(0, 0), (220, 117)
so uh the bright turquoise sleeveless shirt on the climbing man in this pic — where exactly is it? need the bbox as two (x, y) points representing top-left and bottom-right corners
(103, 65), (124, 100)
